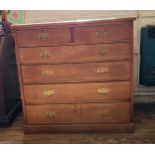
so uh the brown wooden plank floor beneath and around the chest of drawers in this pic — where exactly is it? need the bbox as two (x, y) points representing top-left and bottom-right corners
(0, 103), (155, 144)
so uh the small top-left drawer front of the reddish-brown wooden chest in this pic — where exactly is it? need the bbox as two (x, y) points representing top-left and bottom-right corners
(17, 28), (71, 47)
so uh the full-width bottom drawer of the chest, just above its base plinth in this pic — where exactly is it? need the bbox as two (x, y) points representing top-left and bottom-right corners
(26, 102), (130, 124)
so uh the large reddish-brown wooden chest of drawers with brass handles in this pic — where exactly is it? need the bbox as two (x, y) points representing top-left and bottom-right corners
(12, 19), (133, 133)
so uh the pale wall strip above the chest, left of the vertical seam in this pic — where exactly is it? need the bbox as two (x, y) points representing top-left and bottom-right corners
(25, 10), (137, 23)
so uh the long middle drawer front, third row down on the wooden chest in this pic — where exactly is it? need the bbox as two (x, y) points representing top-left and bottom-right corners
(22, 62), (130, 84)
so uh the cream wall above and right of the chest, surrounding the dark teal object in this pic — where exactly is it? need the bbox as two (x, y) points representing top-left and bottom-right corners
(22, 10), (155, 103)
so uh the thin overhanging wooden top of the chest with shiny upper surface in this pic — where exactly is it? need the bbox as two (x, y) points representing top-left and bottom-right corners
(11, 17), (135, 30)
